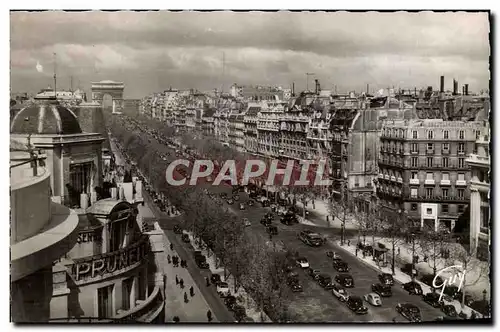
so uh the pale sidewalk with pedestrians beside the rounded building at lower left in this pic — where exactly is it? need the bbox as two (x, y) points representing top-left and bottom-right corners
(137, 204), (217, 323)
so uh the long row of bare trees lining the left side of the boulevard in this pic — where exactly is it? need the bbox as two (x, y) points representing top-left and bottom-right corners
(108, 113), (294, 321)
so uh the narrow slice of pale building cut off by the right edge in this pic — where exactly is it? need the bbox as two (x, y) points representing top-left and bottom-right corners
(466, 127), (491, 260)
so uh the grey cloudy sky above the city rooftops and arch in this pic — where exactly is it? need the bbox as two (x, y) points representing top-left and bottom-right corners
(10, 12), (490, 98)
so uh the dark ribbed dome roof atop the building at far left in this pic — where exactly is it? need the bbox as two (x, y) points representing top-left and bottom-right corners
(10, 100), (82, 135)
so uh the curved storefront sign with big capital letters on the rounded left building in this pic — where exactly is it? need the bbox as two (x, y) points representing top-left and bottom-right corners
(72, 237), (149, 281)
